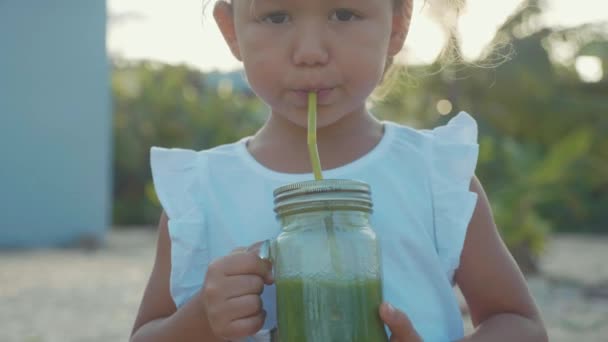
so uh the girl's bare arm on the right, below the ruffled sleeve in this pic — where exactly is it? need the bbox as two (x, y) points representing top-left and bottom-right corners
(455, 177), (548, 342)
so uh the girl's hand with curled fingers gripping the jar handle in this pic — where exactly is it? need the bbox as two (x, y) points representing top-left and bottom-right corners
(199, 244), (273, 341)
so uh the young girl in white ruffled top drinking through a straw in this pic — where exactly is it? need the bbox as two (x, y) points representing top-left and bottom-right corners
(131, 0), (547, 342)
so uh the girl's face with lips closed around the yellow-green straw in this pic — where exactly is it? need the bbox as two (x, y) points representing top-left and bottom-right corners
(214, 0), (409, 127)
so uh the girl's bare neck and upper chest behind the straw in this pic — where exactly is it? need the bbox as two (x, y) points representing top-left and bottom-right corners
(247, 111), (384, 173)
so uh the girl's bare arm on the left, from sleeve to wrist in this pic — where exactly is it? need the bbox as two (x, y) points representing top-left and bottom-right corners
(131, 213), (223, 342)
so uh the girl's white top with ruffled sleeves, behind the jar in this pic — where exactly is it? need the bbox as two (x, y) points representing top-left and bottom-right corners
(151, 113), (478, 341)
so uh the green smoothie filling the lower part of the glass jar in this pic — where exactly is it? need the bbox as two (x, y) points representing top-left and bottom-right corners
(276, 278), (388, 342)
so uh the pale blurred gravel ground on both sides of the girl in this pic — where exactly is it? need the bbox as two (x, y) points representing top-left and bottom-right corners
(0, 229), (608, 342)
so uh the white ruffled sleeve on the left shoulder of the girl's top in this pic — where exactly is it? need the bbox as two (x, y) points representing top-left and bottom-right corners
(150, 147), (209, 307)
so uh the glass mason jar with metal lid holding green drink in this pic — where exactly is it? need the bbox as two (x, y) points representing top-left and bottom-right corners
(260, 180), (388, 342)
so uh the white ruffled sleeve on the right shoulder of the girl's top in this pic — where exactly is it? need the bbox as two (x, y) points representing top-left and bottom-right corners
(430, 112), (479, 281)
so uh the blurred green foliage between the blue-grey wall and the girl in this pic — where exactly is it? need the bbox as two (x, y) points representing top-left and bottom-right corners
(112, 62), (264, 225)
